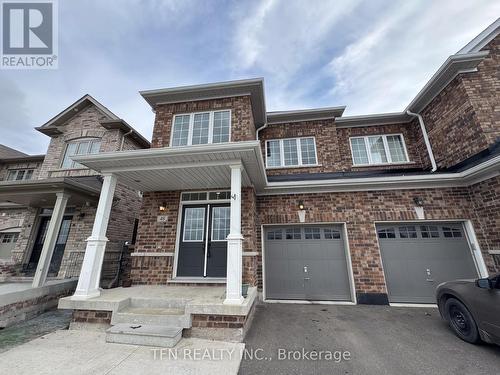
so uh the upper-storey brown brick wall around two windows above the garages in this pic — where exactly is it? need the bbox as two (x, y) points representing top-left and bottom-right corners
(259, 120), (428, 176)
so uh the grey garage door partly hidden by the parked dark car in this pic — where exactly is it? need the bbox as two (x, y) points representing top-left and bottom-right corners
(377, 223), (478, 303)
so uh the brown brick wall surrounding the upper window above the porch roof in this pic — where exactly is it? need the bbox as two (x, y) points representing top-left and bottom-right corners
(151, 96), (255, 147)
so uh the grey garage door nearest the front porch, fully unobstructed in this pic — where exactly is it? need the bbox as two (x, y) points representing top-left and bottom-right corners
(264, 225), (352, 301)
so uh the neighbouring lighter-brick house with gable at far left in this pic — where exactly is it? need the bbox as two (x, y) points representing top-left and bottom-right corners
(0, 95), (149, 286)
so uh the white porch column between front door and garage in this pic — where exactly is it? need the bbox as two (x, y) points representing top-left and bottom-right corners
(224, 164), (244, 305)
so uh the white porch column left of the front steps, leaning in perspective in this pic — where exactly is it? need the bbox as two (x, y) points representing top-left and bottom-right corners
(72, 174), (116, 299)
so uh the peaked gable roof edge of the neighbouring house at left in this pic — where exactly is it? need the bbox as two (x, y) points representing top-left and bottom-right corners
(35, 94), (150, 148)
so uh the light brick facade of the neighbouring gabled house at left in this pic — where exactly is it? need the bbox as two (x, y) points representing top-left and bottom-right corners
(0, 101), (146, 284)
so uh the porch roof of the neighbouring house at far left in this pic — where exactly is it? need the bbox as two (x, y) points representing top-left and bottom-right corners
(0, 176), (101, 207)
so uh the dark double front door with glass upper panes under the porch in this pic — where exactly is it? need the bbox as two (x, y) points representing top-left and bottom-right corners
(177, 204), (230, 277)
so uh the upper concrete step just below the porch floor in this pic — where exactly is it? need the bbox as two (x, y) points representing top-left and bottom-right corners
(111, 307), (191, 328)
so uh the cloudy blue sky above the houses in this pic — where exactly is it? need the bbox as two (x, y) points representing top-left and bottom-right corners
(0, 0), (500, 153)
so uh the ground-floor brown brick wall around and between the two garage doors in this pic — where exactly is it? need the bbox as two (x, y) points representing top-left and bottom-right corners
(257, 181), (499, 293)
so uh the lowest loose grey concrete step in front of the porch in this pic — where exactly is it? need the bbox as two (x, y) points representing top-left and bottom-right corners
(106, 324), (182, 348)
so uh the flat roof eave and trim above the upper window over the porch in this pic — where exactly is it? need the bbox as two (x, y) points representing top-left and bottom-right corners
(139, 78), (266, 128)
